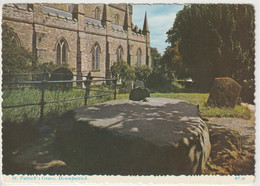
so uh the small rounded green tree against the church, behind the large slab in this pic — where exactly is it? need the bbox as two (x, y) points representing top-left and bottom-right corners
(111, 59), (135, 86)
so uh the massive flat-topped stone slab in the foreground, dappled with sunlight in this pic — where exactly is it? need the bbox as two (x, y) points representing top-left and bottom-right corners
(56, 98), (211, 175)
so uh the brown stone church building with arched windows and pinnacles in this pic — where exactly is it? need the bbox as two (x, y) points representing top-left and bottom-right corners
(2, 4), (151, 77)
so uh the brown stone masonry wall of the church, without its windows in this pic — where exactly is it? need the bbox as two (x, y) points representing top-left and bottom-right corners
(2, 4), (150, 77)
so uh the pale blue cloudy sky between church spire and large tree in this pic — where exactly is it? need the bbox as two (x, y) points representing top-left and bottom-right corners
(133, 4), (184, 54)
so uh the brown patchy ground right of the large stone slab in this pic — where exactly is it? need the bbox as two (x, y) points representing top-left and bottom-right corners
(206, 118), (255, 175)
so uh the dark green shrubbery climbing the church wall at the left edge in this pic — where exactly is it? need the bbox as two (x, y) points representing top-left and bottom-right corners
(2, 24), (74, 81)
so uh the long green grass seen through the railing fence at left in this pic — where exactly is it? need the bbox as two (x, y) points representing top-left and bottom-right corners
(2, 88), (113, 122)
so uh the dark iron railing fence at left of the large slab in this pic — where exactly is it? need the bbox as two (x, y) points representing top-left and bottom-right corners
(2, 73), (117, 122)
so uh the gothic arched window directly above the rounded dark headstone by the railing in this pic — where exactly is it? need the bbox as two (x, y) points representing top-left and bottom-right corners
(56, 39), (68, 64)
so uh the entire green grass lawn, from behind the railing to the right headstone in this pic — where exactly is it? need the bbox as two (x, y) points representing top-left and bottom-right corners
(2, 86), (251, 122)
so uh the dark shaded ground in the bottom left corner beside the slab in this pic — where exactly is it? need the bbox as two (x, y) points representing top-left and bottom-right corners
(3, 130), (69, 174)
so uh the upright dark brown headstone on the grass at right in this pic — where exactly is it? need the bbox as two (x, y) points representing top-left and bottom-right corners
(207, 77), (241, 108)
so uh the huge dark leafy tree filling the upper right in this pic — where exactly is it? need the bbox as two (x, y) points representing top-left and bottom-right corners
(167, 4), (255, 102)
